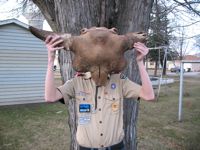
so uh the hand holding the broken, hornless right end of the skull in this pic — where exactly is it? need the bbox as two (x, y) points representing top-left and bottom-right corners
(133, 42), (149, 62)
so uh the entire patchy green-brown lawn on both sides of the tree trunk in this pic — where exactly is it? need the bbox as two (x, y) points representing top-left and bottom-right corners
(0, 75), (200, 150)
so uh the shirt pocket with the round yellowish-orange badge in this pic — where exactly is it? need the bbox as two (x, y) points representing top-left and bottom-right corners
(105, 95), (121, 114)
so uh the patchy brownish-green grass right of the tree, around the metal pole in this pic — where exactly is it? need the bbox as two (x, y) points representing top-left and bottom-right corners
(138, 75), (200, 150)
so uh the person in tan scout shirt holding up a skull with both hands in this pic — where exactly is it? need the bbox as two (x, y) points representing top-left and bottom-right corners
(45, 36), (154, 150)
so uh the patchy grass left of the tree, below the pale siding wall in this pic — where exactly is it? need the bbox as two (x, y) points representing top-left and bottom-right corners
(0, 103), (70, 150)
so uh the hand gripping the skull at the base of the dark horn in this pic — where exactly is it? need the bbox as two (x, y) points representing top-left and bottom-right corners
(45, 35), (64, 62)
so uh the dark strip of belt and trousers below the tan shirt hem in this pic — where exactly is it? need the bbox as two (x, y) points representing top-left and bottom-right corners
(79, 141), (124, 150)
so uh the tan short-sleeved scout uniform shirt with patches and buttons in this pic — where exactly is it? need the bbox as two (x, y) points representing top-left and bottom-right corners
(58, 74), (141, 148)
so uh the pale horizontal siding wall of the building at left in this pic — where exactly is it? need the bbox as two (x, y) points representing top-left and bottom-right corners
(0, 24), (47, 105)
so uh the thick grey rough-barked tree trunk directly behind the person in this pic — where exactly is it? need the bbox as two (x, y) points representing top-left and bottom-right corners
(33, 0), (153, 150)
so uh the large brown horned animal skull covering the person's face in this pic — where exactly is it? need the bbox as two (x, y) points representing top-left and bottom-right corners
(29, 27), (147, 86)
